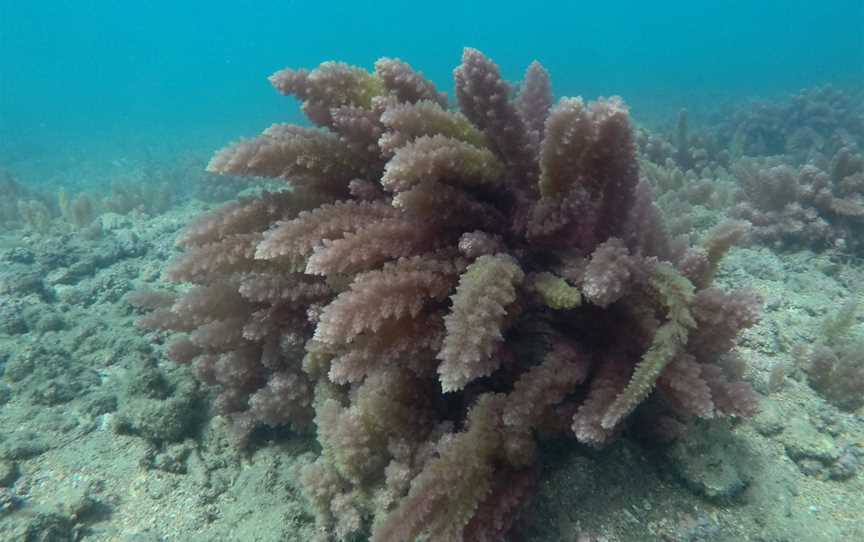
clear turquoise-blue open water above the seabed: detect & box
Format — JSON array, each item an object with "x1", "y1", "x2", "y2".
[{"x1": 0, "y1": 0, "x2": 864, "y2": 187}]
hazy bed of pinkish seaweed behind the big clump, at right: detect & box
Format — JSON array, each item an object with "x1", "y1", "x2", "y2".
[{"x1": 637, "y1": 85, "x2": 864, "y2": 253}]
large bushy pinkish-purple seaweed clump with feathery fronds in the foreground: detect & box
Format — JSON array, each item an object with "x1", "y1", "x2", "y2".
[{"x1": 138, "y1": 49, "x2": 760, "y2": 542}]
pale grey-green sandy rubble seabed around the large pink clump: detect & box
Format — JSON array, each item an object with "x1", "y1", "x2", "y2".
[{"x1": 0, "y1": 202, "x2": 864, "y2": 542}]
